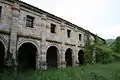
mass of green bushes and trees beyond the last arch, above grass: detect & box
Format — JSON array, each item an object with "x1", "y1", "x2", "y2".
[{"x1": 85, "y1": 37, "x2": 120, "y2": 64}]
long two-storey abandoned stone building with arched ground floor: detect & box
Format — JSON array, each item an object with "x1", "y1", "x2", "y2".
[{"x1": 0, "y1": 0, "x2": 104, "y2": 71}]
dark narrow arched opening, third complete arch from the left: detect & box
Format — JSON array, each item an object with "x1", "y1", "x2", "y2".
[{"x1": 65, "y1": 48, "x2": 73, "y2": 67}]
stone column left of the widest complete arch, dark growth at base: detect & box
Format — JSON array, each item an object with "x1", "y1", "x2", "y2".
[{"x1": 6, "y1": 3, "x2": 20, "y2": 69}]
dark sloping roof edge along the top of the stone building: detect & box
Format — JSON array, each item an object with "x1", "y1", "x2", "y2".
[{"x1": 5, "y1": 0, "x2": 105, "y2": 41}]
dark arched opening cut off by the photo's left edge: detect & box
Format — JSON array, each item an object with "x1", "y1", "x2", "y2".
[{"x1": 0, "y1": 42, "x2": 5, "y2": 72}]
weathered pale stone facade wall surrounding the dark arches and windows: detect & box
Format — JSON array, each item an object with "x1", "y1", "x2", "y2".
[{"x1": 0, "y1": 0, "x2": 104, "y2": 69}]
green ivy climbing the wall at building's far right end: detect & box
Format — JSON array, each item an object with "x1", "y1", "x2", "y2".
[{"x1": 85, "y1": 31, "x2": 106, "y2": 64}]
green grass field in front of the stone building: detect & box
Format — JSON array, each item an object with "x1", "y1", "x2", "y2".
[{"x1": 0, "y1": 63, "x2": 120, "y2": 80}]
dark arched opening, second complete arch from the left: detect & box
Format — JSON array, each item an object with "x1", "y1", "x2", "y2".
[{"x1": 46, "y1": 46, "x2": 58, "y2": 68}]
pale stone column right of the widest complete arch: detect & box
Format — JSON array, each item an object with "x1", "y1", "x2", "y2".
[{"x1": 39, "y1": 15, "x2": 47, "y2": 69}]
